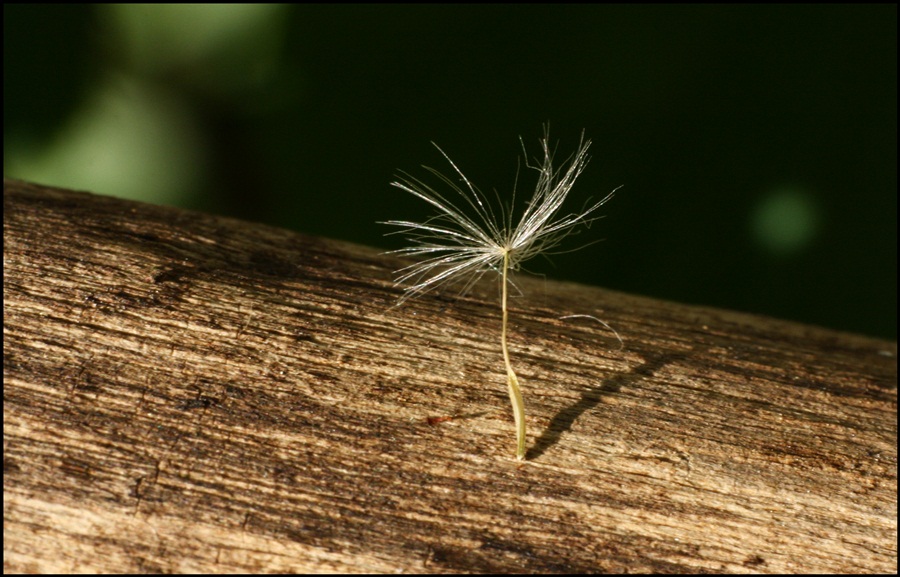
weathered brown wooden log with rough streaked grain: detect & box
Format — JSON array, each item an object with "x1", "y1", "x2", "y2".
[{"x1": 3, "y1": 181, "x2": 897, "y2": 573}]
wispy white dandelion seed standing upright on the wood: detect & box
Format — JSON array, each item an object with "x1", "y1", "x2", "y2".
[{"x1": 383, "y1": 126, "x2": 618, "y2": 460}]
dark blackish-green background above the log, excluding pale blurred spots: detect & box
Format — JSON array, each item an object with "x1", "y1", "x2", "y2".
[{"x1": 3, "y1": 5, "x2": 897, "y2": 339}]
